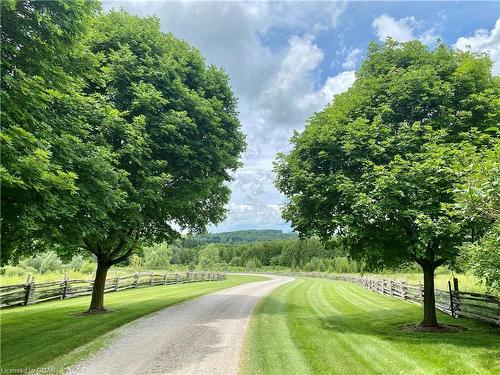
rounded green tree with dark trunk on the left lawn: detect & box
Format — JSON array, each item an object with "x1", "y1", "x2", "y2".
[{"x1": 73, "y1": 11, "x2": 245, "y2": 311}]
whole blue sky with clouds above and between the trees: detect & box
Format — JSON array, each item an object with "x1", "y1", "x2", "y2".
[{"x1": 104, "y1": 0, "x2": 500, "y2": 232}]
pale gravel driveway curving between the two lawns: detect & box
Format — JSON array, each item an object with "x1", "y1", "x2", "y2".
[{"x1": 68, "y1": 276, "x2": 293, "y2": 375}]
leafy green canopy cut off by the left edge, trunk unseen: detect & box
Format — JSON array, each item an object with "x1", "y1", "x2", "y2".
[{"x1": 0, "y1": 1, "x2": 102, "y2": 262}]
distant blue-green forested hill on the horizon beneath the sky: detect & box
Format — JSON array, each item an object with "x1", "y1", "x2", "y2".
[{"x1": 190, "y1": 229, "x2": 298, "y2": 244}]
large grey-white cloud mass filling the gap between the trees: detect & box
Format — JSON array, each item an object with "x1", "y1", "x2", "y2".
[{"x1": 103, "y1": 1, "x2": 354, "y2": 231}]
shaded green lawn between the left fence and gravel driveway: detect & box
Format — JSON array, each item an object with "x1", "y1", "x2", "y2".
[{"x1": 0, "y1": 275, "x2": 266, "y2": 371}]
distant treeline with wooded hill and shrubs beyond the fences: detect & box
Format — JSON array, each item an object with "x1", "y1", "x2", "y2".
[{"x1": 0, "y1": 230, "x2": 364, "y2": 276}]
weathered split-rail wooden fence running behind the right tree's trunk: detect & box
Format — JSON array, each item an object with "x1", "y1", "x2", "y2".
[{"x1": 254, "y1": 272, "x2": 500, "y2": 325}]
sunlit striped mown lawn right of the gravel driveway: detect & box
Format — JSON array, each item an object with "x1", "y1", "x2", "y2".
[{"x1": 242, "y1": 278, "x2": 500, "y2": 375}]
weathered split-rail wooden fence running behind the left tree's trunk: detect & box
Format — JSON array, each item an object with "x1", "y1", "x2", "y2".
[{"x1": 0, "y1": 272, "x2": 226, "y2": 307}]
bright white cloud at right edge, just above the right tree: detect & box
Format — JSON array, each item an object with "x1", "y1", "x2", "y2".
[{"x1": 454, "y1": 18, "x2": 500, "y2": 75}]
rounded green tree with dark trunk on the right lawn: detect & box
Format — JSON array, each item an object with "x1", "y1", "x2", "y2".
[{"x1": 275, "y1": 39, "x2": 500, "y2": 326}]
